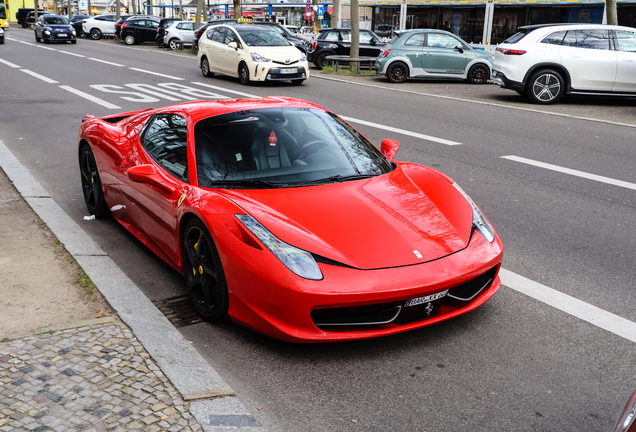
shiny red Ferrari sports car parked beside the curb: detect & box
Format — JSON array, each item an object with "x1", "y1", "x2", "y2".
[{"x1": 79, "y1": 97, "x2": 503, "y2": 342}]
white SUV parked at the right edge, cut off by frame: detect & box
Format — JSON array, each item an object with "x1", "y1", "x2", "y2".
[{"x1": 492, "y1": 24, "x2": 636, "y2": 104}]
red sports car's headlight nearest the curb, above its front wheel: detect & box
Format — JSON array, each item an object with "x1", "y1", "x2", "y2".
[{"x1": 234, "y1": 213, "x2": 323, "y2": 280}]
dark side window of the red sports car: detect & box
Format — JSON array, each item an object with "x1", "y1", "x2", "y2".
[{"x1": 141, "y1": 114, "x2": 188, "y2": 181}]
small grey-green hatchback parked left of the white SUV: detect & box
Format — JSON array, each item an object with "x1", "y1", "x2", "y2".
[{"x1": 375, "y1": 29, "x2": 493, "y2": 84}]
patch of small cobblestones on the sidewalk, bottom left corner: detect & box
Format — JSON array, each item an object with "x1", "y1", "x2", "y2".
[{"x1": 0, "y1": 322, "x2": 201, "y2": 432}]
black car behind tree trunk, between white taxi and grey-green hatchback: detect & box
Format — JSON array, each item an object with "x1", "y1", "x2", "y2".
[{"x1": 307, "y1": 28, "x2": 385, "y2": 69}]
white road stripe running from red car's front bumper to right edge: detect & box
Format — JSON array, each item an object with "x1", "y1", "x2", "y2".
[{"x1": 499, "y1": 268, "x2": 636, "y2": 342}]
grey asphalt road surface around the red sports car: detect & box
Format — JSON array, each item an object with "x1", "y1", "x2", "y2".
[{"x1": 0, "y1": 29, "x2": 636, "y2": 432}]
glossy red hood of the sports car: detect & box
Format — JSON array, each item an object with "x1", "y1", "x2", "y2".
[{"x1": 223, "y1": 164, "x2": 472, "y2": 269}]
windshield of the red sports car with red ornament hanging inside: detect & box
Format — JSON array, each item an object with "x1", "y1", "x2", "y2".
[{"x1": 194, "y1": 108, "x2": 393, "y2": 189}]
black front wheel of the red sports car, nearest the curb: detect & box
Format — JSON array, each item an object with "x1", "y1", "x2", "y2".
[{"x1": 181, "y1": 218, "x2": 229, "y2": 322}]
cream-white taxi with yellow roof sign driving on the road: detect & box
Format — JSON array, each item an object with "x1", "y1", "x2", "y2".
[{"x1": 198, "y1": 24, "x2": 309, "y2": 84}]
